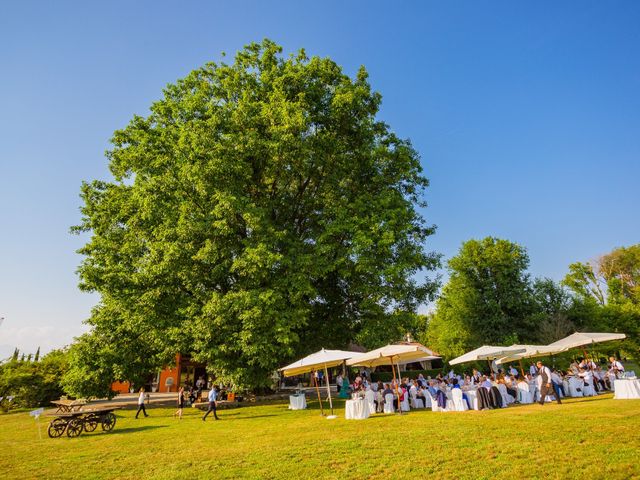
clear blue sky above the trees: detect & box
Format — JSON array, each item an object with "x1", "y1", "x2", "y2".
[{"x1": 0, "y1": 0, "x2": 640, "y2": 358}]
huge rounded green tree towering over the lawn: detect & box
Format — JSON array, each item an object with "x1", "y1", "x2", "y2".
[{"x1": 70, "y1": 40, "x2": 438, "y2": 387}]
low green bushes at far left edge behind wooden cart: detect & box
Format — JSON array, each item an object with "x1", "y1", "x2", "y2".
[{"x1": 0, "y1": 350, "x2": 68, "y2": 409}]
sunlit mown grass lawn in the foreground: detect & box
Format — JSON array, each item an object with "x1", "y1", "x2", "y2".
[{"x1": 0, "y1": 395, "x2": 640, "y2": 480}]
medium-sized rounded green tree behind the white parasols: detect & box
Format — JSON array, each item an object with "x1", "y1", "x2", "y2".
[{"x1": 427, "y1": 237, "x2": 536, "y2": 357}]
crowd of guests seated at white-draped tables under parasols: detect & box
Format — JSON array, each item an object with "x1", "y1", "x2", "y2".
[{"x1": 336, "y1": 357, "x2": 624, "y2": 412}]
